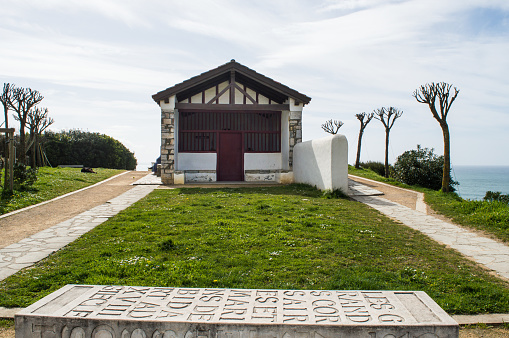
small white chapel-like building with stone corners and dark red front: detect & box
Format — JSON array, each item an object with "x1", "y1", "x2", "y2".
[{"x1": 152, "y1": 60, "x2": 311, "y2": 184}]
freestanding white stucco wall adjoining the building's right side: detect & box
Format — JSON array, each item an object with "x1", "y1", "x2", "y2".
[{"x1": 293, "y1": 135, "x2": 348, "y2": 194}]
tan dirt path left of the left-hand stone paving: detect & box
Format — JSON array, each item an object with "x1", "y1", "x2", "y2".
[{"x1": 0, "y1": 171, "x2": 149, "y2": 248}]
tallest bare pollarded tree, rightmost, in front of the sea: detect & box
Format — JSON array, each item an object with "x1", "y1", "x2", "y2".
[{"x1": 413, "y1": 82, "x2": 460, "y2": 192}]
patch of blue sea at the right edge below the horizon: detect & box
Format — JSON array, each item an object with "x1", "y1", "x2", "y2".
[{"x1": 451, "y1": 165, "x2": 509, "y2": 200}]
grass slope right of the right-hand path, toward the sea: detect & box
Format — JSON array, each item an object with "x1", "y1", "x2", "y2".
[{"x1": 348, "y1": 167, "x2": 509, "y2": 243}]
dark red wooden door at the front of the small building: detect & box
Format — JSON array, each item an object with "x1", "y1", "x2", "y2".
[{"x1": 217, "y1": 133, "x2": 244, "y2": 181}]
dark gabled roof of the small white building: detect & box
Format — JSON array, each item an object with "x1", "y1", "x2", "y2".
[{"x1": 152, "y1": 60, "x2": 311, "y2": 104}]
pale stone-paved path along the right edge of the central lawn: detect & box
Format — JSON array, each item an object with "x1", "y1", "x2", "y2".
[{"x1": 352, "y1": 196, "x2": 509, "y2": 279}]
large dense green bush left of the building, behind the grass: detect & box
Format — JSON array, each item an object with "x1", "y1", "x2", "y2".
[{"x1": 42, "y1": 130, "x2": 137, "y2": 170}]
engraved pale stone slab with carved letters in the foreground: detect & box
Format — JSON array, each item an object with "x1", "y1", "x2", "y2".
[{"x1": 15, "y1": 285, "x2": 459, "y2": 338}]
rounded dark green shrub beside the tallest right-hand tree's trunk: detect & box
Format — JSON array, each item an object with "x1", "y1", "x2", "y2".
[{"x1": 394, "y1": 145, "x2": 458, "y2": 191}]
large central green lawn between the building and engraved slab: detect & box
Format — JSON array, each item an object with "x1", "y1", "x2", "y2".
[{"x1": 0, "y1": 185, "x2": 509, "y2": 314}]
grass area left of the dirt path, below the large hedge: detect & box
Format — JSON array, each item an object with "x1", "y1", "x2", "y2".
[{"x1": 0, "y1": 167, "x2": 125, "y2": 215}]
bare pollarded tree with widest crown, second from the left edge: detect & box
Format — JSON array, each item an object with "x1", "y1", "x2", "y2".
[{"x1": 11, "y1": 87, "x2": 44, "y2": 164}]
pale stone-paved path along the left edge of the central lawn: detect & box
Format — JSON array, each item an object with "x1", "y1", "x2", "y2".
[{"x1": 0, "y1": 184, "x2": 157, "y2": 280}]
